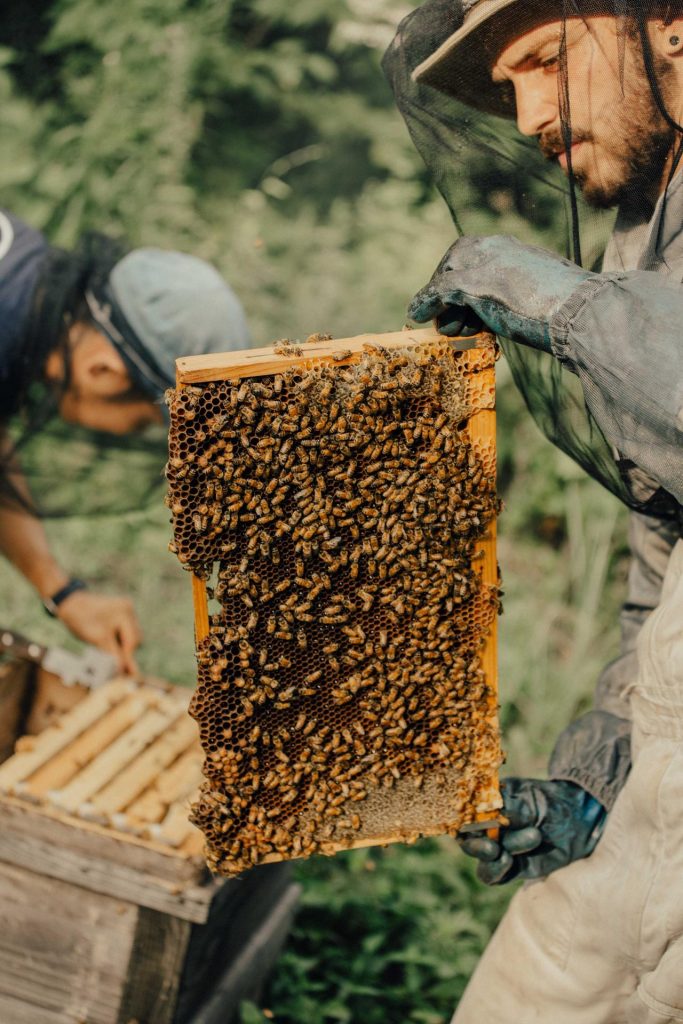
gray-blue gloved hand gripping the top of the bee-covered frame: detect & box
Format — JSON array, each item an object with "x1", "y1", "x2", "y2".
[{"x1": 408, "y1": 236, "x2": 597, "y2": 351}]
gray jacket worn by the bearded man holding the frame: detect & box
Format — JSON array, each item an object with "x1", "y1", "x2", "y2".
[{"x1": 549, "y1": 173, "x2": 683, "y2": 808}]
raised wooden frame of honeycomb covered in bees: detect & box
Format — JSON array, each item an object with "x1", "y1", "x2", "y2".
[{"x1": 168, "y1": 330, "x2": 501, "y2": 873}]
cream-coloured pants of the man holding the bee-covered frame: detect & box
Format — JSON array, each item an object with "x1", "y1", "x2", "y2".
[{"x1": 453, "y1": 541, "x2": 683, "y2": 1024}]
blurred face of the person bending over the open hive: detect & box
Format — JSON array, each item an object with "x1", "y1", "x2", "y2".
[{"x1": 45, "y1": 323, "x2": 163, "y2": 434}]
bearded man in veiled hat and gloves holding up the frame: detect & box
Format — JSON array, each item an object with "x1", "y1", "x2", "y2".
[{"x1": 385, "y1": 0, "x2": 683, "y2": 1024}]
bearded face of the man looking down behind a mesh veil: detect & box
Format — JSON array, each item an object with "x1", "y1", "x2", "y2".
[{"x1": 492, "y1": 16, "x2": 676, "y2": 207}]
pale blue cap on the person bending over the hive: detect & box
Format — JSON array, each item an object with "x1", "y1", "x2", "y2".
[{"x1": 86, "y1": 249, "x2": 250, "y2": 408}]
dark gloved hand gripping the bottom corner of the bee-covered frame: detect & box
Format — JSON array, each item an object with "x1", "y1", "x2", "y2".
[{"x1": 459, "y1": 778, "x2": 607, "y2": 886}]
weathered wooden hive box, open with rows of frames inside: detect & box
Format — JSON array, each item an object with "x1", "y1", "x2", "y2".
[{"x1": 0, "y1": 665, "x2": 296, "y2": 1024}]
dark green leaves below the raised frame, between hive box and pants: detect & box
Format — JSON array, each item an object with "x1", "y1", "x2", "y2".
[{"x1": 242, "y1": 840, "x2": 510, "y2": 1024}]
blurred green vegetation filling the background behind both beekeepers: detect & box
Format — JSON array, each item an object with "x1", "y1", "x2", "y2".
[{"x1": 0, "y1": 0, "x2": 625, "y2": 1024}]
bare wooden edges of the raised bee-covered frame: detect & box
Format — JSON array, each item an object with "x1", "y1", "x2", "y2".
[{"x1": 176, "y1": 321, "x2": 502, "y2": 862}]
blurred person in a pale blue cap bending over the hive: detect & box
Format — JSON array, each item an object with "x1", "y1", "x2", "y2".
[{"x1": 0, "y1": 211, "x2": 249, "y2": 673}]
